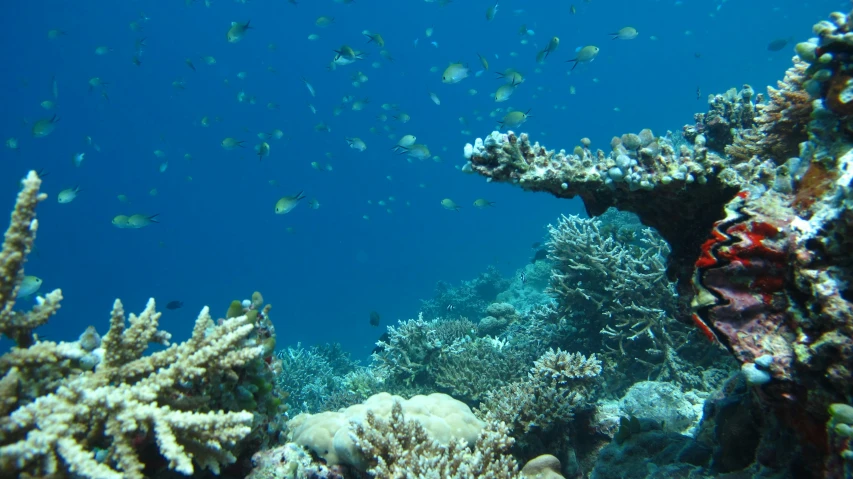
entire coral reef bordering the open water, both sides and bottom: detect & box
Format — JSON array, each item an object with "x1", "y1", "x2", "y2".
[{"x1": 5, "y1": 6, "x2": 853, "y2": 479}]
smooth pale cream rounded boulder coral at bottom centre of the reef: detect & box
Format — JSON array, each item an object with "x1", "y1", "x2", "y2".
[{"x1": 288, "y1": 393, "x2": 485, "y2": 471}]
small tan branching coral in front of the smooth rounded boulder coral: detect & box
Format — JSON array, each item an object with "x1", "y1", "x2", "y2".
[{"x1": 350, "y1": 401, "x2": 522, "y2": 479}]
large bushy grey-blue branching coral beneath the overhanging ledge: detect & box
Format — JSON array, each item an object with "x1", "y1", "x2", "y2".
[{"x1": 547, "y1": 213, "x2": 716, "y2": 392}]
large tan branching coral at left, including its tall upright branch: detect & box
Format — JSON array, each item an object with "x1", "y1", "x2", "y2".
[{"x1": 0, "y1": 172, "x2": 264, "y2": 479}]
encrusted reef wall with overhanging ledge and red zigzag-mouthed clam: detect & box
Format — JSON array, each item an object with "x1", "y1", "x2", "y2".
[{"x1": 465, "y1": 7, "x2": 853, "y2": 477}]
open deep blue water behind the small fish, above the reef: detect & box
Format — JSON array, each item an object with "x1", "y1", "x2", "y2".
[{"x1": 0, "y1": 0, "x2": 848, "y2": 356}]
